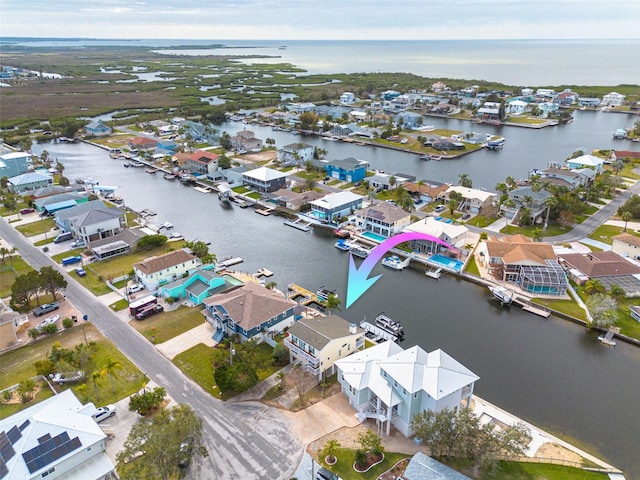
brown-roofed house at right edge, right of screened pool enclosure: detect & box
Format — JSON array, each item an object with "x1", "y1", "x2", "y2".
[{"x1": 558, "y1": 251, "x2": 640, "y2": 297}]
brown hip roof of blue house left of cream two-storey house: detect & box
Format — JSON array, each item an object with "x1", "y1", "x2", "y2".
[{"x1": 204, "y1": 282, "x2": 297, "y2": 331}]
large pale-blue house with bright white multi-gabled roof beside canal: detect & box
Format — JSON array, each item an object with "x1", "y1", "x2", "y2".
[{"x1": 336, "y1": 342, "x2": 479, "y2": 437}]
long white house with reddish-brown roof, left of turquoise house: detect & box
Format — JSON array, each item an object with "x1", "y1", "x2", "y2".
[{"x1": 133, "y1": 250, "x2": 201, "y2": 291}]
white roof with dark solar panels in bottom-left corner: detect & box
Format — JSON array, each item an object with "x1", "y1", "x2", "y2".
[{"x1": 0, "y1": 390, "x2": 114, "y2": 480}]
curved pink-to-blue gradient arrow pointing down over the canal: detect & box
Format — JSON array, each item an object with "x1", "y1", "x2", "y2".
[{"x1": 346, "y1": 232, "x2": 451, "y2": 308}]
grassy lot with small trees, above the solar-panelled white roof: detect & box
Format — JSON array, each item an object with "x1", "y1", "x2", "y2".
[{"x1": 0, "y1": 323, "x2": 144, "y2": 418}]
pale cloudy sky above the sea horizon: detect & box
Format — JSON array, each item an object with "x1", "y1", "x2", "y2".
[{"x1": 0, "y1": 0, "x2": 640, "y2": 40}]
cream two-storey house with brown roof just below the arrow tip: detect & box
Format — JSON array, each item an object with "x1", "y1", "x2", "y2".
[{"x1": 283, "y1": 315, "x2": 365, "y2": 380}]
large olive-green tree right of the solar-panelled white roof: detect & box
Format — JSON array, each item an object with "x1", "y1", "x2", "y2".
[{"x1": 116, "y1": 405, "x2": 208, "y2": 480}]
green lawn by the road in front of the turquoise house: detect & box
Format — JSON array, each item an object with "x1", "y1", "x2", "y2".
[{"x1": 129, "y1": 306, "x2": 204, "y2": 343}]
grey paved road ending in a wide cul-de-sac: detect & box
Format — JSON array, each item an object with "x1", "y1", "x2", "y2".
[{"x1": 0, "y1": 218, "x2": 303, "y2": 480}]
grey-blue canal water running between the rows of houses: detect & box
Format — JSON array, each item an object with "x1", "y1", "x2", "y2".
[{"x1": 33, "y1": 112, "x2": 640, "y2": 479}]
